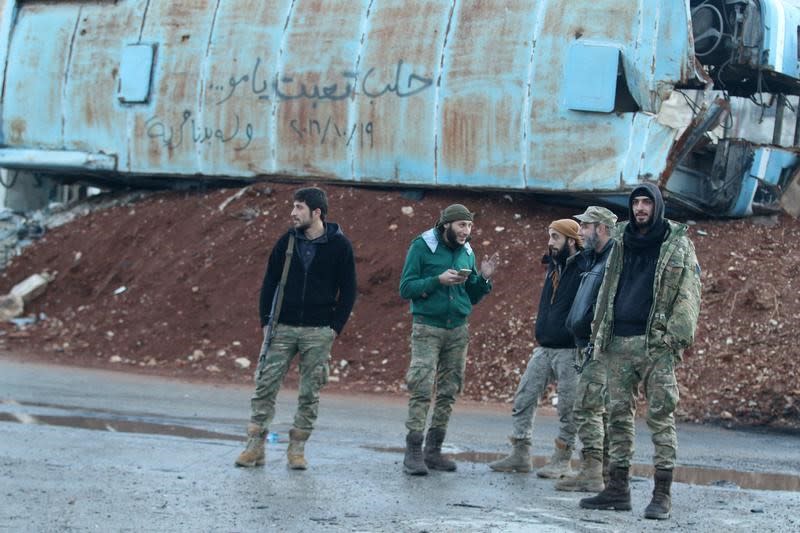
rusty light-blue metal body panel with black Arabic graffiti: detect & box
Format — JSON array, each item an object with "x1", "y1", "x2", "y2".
[{"x1": 3, "y1": 0, "x2": 690, "y2": 190}]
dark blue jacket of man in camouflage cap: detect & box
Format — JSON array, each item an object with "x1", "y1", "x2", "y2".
[{"x1": 566, "y1": 239, "x2": 614, "y2": 348}]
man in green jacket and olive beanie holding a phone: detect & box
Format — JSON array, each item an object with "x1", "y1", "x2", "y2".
[{"x1": 400, "y1": 204, "x2": 500, "y2": 475}]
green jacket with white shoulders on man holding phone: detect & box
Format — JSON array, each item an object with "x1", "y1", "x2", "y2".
[{"x1": 400, "y1": 228, "x2": 492, "y2": 329}]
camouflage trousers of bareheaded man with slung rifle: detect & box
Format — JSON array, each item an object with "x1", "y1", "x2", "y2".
[{"x1": 250, "y1": 324, "x2": 336, "y2": 431}]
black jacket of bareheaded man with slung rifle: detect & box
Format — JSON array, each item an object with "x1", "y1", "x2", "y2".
[{"x1": 259, "y1": 222, "x2": 356, "y2": 334}]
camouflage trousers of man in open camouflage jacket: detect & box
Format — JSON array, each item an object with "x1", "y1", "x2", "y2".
[{"x1": 599, "y1": 335, "x2": 678, "y2": 470}]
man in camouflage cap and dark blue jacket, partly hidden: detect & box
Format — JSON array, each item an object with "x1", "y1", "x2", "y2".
[{"x1": 556, "y1": 205, "x2": 617, "y2": 492}]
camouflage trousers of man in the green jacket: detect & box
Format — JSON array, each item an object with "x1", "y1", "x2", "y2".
[{"x1": 406, "y1": 323, "x2": 469, "y2": 431}]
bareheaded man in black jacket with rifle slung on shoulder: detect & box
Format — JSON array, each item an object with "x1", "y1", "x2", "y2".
[{"x1": 236, "y1": 187, "x2": 356, "y2": 470}]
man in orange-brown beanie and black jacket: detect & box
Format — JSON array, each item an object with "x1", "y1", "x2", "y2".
[{"x1": 489, "y1": 219, "x2": 583, "y2": 478}]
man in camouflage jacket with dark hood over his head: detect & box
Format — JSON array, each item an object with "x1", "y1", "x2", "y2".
[{"x1": 580, "y1": 182, "x2": 700, "y2": 520}]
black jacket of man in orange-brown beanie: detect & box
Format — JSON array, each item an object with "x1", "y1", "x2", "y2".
[{"x1": 536, "y1": 250, "x2": 584, "y2": 348}]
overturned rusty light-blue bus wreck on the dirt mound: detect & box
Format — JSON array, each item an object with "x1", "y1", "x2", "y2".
[{"x1": 0, "y1": 0, "x2": 800, "y2": 217}]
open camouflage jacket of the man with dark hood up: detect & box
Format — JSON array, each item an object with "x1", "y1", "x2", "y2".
[{"x1": 592, "y1": 220, "x2": 700, "y2": 359}]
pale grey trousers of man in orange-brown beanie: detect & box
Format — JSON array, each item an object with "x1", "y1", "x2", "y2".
[{"x1": 511, "y1": 346, "x2": 578, "y2": 446}]
